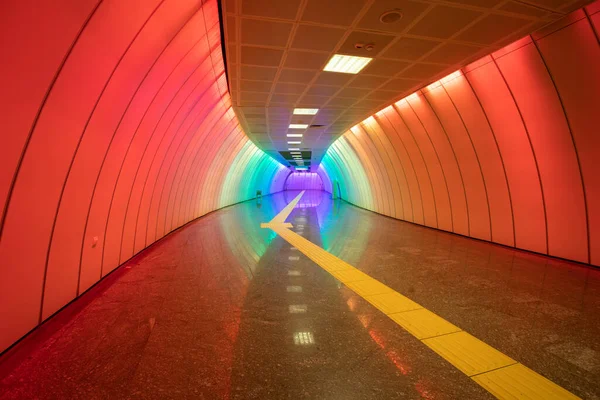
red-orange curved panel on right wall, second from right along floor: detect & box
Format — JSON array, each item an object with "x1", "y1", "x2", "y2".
[{"x1": 496, "y1": 37, "x2": 588, "y2": 262}]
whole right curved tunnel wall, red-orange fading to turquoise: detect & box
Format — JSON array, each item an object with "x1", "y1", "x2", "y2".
[{"x1": 321, "y1": 3, "x2": 600, "y2": 265}]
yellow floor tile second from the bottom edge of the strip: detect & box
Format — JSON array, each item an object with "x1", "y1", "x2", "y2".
[{"x1": 423, "y1": 331, "x2": 516, "y2": 376}]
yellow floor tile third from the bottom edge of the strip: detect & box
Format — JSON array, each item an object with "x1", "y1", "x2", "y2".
[{"x1": 388, "y1": 308, "x2": 460, "y2": 339}]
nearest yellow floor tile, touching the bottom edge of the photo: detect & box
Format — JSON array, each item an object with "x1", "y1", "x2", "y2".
[{"x1": 472, "y1": 364, "x2": 579, "y2": 400}]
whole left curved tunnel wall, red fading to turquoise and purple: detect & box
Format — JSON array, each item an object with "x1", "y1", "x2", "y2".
[{"x1": 0, "y1": 0, "x2": 289, "y2": 352}]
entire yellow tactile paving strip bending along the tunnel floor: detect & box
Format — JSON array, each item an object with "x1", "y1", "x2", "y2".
[{"x1": 261, "y1": 191, "x2": 579, "y2": 400}]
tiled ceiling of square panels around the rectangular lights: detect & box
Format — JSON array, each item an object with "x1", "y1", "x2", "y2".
[{"x1": 222, "y1": 0, "x2": 589, "y2": 169}]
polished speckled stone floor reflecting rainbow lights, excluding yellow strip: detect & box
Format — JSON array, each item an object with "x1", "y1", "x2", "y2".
[{"x1": 0, "y1": 192, "x2": 600, "y2": 399}]
